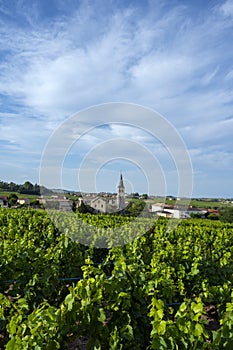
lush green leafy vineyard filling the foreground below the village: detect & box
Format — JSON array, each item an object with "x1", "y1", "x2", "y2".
[{"x1": 0, "y1": 209, "x2": 233, "y2": 350}]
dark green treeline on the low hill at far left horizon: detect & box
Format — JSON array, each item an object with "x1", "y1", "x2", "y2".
[{"x1": 0, "y1": 181, "x2": 53, "y2": 195}]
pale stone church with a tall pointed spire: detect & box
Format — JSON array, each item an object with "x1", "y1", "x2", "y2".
[{"x1": 88, "y1": 174, "x2": 126, "y2": 213}]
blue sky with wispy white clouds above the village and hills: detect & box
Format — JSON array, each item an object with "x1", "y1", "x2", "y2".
[{"x1": 0, "y1": 0, "x2": 233, "y2": 198}]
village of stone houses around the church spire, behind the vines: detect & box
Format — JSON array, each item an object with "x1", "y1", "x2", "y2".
[{"x1": 0, "y1": 174, "x2": 220, "y2": 219}]
